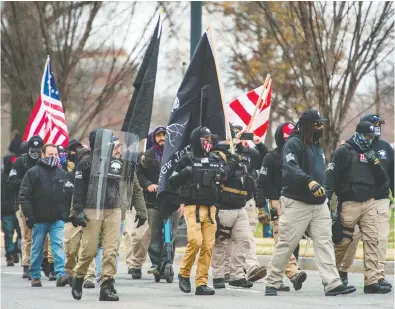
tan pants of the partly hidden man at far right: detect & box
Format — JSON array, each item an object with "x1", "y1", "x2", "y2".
[{"x1": 339, "y1": 199, "x2": 391, "y2": 279}]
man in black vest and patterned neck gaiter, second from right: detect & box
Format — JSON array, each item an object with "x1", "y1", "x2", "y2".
[{"x1": 326, "y1": 121, "x2": 391, "y2": 294}]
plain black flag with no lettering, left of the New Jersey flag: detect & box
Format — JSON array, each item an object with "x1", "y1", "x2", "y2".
[{"x1": 122, "y1": 16, "x2": 162, "y2": 140}]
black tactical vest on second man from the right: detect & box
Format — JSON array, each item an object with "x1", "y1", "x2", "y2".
[{"x1": 347, "y1": 147, "x2": 375, "y2": 202}]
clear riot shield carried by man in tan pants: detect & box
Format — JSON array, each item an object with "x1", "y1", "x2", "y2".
[{"x1": 85, "y1": 129, "x2": 139, "y2": 222}]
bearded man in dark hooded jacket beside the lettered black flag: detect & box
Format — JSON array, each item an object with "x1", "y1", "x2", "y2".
[{"x1": 137, "y1": 126, "x2": 178, "y2": 275}]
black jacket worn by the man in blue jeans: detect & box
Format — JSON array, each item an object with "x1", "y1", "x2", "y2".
[{"x1": 18, "y1": 160, "x2": 73, "y2": 222}]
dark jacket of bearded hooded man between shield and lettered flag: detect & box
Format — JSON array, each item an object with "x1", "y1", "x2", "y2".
[{"x1": 137, "y1": 147, "x2": 160, "y2": 208}]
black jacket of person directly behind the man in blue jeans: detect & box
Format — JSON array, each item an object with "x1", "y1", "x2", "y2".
[{"x1": 8, "y1": 153, "x2": 37, "y2": 211}]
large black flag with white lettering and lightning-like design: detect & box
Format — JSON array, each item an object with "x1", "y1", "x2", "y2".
[{"x1": 158, "y1": 32, "x2": 226, "y2": 218}]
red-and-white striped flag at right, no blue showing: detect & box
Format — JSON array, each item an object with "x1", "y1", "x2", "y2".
[{"x1": 228, "y1": 84, "x2": 272, "y2": 141}]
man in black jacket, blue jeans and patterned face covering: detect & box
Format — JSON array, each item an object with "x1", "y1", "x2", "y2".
[{"x1": 18, "y1": 144, "x2": 73, "y2": 287}]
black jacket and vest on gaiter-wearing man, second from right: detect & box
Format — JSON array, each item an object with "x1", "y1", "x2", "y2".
[{"x1": 325, "y1": 139, "x2": 389, "y2": 202}]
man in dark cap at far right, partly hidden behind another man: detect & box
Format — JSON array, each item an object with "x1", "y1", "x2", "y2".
[{"x1": 339, "y1": 114, "x2": 394, "y2": 283}]
